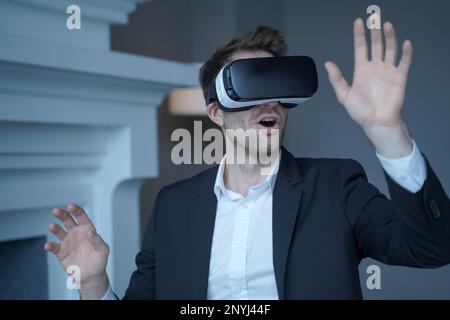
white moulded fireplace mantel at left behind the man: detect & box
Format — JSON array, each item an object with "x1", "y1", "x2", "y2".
[{"x1": 0, "y1": 0, "x2": 198, "y2": 299}]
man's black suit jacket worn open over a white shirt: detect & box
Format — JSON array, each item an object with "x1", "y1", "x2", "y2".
[{"x1": 125, "y1": 149, "x2": 450, "y2": 299}]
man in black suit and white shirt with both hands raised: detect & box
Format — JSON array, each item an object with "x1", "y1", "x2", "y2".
[{"x1": 45, "y1": 19, "x2": 450, "y2": 299}]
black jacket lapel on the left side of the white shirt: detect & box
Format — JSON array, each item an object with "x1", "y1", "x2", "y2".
[{"x1": 189, "y1": 168, "x2": 217, "y2": 300}]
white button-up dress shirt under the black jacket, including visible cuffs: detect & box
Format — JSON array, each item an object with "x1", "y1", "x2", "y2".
[{"x1": 103, "y1": 141, "x2": 426, "y2": 300}]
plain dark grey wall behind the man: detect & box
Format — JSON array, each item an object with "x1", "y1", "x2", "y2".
[{"x1": 111, "y1": 0, "x2": 450, "y2": 299}]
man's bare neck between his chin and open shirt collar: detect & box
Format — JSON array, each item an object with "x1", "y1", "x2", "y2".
[{"x1": 223, "y1": 150, "x2": 280, "y2": 197}]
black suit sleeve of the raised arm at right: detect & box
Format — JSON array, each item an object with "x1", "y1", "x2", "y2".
[{"x1": 341, "y1": 160, "x2": 450, "y2": 268}]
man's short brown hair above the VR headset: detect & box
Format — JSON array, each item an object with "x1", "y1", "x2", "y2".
[{"x1": 199, "y1": 26, "x2": 288, "y2": 100}]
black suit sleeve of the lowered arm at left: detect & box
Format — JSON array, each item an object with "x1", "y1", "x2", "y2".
[{"x1": 123, "y1": 188, "x2": 165, "y2": 300}]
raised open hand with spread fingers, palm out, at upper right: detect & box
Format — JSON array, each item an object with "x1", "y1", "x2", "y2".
[{"x1": 325, "y1": 19, "x2": 412, "y2": 128}]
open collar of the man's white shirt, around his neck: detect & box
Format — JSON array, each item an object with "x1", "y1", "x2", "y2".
[{"x1": 214, "y1": 150, "x2": 281, "y2": 200}]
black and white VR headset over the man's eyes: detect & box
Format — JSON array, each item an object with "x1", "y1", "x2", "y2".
[{"x1": 206, "y1": 56, "x2": 318, "y2": 112}]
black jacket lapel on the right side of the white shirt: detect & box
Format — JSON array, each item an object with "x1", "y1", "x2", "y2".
[{"x1": 272, "y1": 148, "x2": 303, "y2": 299}]
